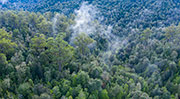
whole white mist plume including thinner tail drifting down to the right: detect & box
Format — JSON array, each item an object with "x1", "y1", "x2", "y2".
[{"x1": 70, "y1": 2, "x2": 128, "y2": 63}]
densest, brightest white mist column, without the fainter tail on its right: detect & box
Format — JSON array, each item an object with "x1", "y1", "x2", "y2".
[{"x1": 71, "y1": 2, "x2": 97, "y2": 43}]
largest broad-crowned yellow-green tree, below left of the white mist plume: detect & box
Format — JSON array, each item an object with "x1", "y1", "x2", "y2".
[{"x1": 49, "y1": 35, "x2": 74, "y2": 72}]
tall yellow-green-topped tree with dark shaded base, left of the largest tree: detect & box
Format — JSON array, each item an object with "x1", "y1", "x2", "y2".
[{"x1": 26, "y1": 33, "x2": 47, "y2": 78}]
